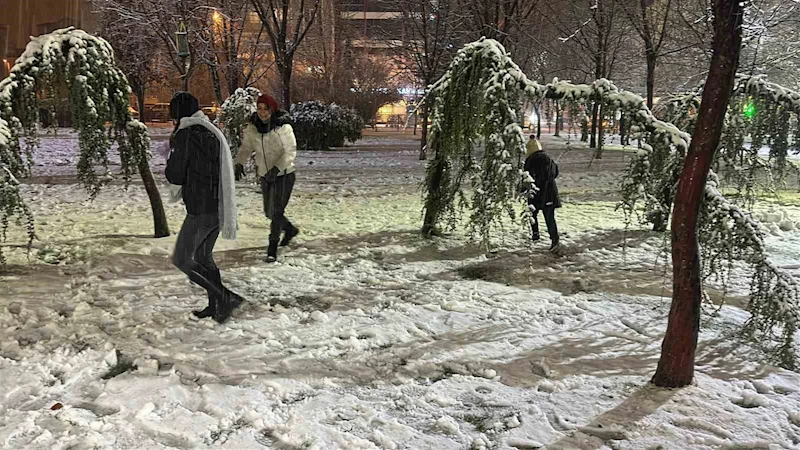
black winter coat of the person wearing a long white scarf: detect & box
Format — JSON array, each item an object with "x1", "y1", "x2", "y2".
[{"x1": 166, "y1": 125, "x2": 220, "y2": 214}]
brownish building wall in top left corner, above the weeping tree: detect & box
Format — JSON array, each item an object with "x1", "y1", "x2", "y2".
[{"x1": 0, "y1": 0, "x2": 97, "y2": 79}]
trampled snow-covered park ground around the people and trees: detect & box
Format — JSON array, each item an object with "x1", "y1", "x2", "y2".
[{"x1": 0, "y1": 137, "x2": 800, "y2": 450}]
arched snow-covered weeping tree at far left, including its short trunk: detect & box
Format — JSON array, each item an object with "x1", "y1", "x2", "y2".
[{"x1": 0, "y1": 28, "x2": 169, "y2": 264}]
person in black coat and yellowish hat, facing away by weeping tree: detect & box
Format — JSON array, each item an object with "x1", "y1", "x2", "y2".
[{"x1": 525, "y1": 135, "x2": 561, "y2": 253}]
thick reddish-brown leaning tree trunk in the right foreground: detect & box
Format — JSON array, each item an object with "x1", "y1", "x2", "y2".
[{"x1": 653, "y1": 0, "x2": 743, "y2": 387}]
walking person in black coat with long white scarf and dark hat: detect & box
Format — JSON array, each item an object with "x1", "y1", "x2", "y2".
[{"x1": 166, "y1": 92, "x2": 242, "y2": 323}]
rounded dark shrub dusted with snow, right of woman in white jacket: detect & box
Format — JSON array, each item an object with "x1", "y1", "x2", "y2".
[{"x1": 290, "y1": 101, "x2": 364, "y2": 150}]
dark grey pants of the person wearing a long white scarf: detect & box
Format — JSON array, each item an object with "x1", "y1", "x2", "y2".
[{"x1": 172, "y1": 213, "x2": 225, "y2": 298}]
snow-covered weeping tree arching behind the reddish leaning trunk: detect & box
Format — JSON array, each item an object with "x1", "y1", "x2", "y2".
[{"x1": 422, "y1": 39, "x2": 800, "y2": 366}]
